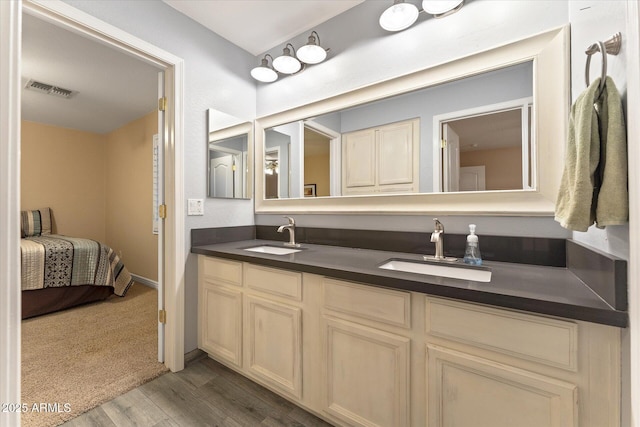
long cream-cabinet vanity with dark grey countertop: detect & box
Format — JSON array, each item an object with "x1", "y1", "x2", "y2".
[{"x1": 192, "y1": 240, "x2": 627, "y2": 427}]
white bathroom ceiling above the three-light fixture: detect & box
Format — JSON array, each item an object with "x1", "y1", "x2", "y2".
[{"x1": 163, "y1": 0, "x2": 364, "y2": 56}]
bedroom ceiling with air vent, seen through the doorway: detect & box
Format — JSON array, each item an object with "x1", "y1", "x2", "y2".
[{"x1": 21, "y1": 14, "x2": 159, "y2": 134}]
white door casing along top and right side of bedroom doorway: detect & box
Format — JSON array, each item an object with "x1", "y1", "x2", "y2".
[{"x1": 16, "y1": 0, "x2": 187, "y2": 378}]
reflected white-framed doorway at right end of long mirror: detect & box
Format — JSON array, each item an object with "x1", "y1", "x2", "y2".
[{"x1": 434, "y1": 98, "x2": 533, "y2": 191}]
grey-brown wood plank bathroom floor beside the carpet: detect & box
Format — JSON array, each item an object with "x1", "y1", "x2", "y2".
[{"x1": 63, "y1": 357, "x2": 331, "y2": 427}]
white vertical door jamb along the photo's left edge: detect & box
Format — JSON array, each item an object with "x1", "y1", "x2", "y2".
[{"x1": 0, "y1": 1, "x2": 22, "y2": 426}]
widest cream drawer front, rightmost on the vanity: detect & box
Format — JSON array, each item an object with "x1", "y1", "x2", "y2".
[{"x1": 426, "y1": 298, "x2": 578, "y2": 371}]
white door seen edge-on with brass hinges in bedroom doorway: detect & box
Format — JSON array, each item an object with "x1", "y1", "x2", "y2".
[{"x1": 154, "y1": 71, "x2": 166, "y2": 363}]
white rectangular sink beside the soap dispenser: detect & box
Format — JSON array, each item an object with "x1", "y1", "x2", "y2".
[{"x1": 379, "y1": 259, "x2": 491, "y2": 282}]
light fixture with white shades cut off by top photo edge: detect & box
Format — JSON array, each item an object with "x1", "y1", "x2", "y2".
[{"x1": 380, "y1": 0, "x2": 464, "y2": 31}]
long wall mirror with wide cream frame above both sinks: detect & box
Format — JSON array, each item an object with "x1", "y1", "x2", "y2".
[{"x1": 255, "y1": 28, "x2": 569, "y2": 215}]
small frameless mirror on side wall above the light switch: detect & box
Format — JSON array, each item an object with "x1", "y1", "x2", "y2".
[{"x1": 207, "y1": 109, "x2": 253, "y2": 199}]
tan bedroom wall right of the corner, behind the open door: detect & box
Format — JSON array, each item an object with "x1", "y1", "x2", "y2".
[{"x1": 105, "y1": 111, "x2": 158, "y2": 281}]
